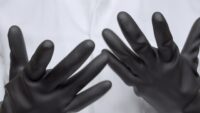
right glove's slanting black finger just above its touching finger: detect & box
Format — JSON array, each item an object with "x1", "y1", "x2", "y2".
[{"x1": 102, "y1": 29, "x2": 143, "y2": 72}]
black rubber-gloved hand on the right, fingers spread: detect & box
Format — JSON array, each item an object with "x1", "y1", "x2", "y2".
[{"x1": 103, "y1": 12, "x2": 200, "y2": 113}]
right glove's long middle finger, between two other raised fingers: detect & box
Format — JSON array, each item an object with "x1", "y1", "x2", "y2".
[{"x1": 118, "y1": 12, "x2": 155, "y2": 62}]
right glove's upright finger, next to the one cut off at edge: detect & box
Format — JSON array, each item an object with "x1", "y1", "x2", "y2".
[{"x1": 152, "y1": 12, "x2": 177, "y2": 61}]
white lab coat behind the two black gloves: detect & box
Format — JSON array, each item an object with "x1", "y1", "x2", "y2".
[{"x1": 0, "y1": 0, "x2": 200, "y2": 113}]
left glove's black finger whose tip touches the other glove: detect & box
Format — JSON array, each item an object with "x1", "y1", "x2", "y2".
[{"x1": 65, "y1": 53, "x2": 108, "y2": 94}]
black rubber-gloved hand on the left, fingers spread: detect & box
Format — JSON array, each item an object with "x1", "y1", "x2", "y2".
[{"x1": 0, "y1": 26, "x2": 111, "y2": 113}]
